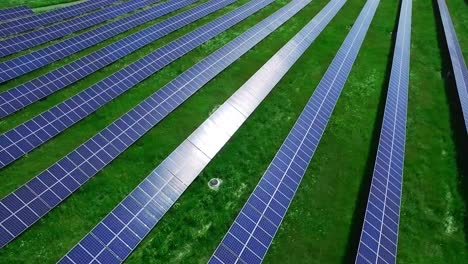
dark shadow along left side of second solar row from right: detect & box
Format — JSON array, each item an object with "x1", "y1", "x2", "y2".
[{"x1": 342, "y1": 1, "x2": 402, "y2": 263}]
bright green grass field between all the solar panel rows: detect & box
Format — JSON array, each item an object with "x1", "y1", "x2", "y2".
[{"x1": 0, "y1": 0, "x2": 468, "y2": 263}]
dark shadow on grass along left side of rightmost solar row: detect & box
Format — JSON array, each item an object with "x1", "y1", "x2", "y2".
[{"x1": 432, "y1": 0, "x2": 468, "y2": 246}]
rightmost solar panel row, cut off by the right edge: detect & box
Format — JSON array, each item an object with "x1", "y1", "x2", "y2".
[{"x1": 437, "y1": 0, "x2": 468, "y2": 132}]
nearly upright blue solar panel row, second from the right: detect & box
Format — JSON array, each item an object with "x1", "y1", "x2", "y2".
[{"x1": 356, "y1": 0, "x2": 412, "y2": 264}]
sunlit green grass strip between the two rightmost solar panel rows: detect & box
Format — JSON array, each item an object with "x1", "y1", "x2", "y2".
[{"x1": 399, "y1": 1, "x2": 468, "y2": 263}]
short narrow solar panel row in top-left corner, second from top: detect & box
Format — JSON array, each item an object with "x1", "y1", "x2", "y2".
[{"x1": 0, "y1": 0, "x2": 118, "y2": 38}]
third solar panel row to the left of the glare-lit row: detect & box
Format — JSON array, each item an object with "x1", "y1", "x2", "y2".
[{"x1": 0, "y1": 0, "x2": 230, "y2": 118}]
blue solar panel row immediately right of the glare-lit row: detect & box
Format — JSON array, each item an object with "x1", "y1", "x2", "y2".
[{"x1": 209, "y1": 0, "x2": 379, "y2": 264}]
